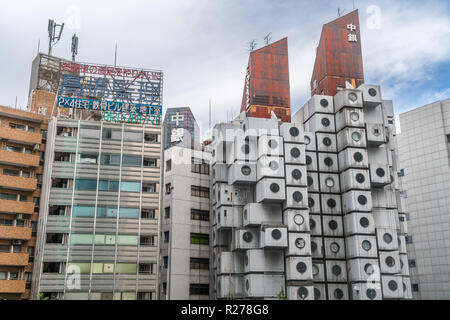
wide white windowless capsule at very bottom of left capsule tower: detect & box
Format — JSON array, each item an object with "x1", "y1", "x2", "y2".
[{"x1": 244, "y1": 274, "x2": 285, "y2": 298}]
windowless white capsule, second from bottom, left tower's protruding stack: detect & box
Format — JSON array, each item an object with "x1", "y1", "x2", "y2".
[{"x1": 244, "y1": 249, "x2": 284, "y2": 273}]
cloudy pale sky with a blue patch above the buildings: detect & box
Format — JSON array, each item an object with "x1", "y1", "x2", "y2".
[{"x1": 0, "y1": 0, "x2": 450, "y2": 136}]
